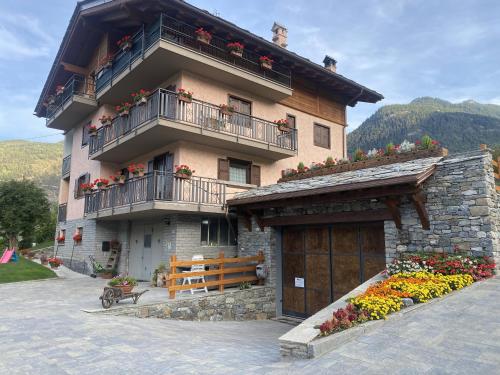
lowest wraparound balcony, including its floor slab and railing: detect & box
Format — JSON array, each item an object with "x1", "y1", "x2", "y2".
[{"x1": 84, "y1": 172, "x2": 226, "y2": 219}]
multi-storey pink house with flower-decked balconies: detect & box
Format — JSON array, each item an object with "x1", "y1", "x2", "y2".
[{"x1": 35, "y1": 0, "x2": 382, "y2": 280}]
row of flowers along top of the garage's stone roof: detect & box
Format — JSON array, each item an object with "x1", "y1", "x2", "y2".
[{"x1": 278, "y1": 137, "x2": 448, "y2": 182}]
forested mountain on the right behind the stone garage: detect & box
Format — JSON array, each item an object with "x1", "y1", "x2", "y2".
[{"x1": 347, "y1": 97, "x2": 500, "y2": 154}]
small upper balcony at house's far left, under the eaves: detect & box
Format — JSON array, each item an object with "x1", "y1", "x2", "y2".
[{"x1": 45, "y1": 75, "x2": 97, "y2": 131}]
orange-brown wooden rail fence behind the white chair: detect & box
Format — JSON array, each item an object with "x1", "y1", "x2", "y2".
[{"x1": 168, "y1": 251, "x2": 264, "y2": 299}]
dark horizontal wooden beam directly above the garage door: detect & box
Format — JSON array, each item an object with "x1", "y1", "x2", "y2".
[{"x1": 262, "y1": 209, "x2": 392, "y2": 227}]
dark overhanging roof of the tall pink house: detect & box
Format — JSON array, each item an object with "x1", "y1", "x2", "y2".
[{"x1": 35, "y1": 0, "x2": 384, "y2": 115}]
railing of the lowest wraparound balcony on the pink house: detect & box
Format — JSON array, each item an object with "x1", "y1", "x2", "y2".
[{"x1": 84, "y1": 171, "x2": 226, "y2": 214}]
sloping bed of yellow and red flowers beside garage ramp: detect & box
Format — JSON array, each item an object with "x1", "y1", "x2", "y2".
[{"x1": 315, "y1": 253, "x2": 495, "y2": 336}]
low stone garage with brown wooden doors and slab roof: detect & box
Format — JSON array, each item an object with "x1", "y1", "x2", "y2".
[{"x1": 228, "y1": 150, "x2": 500, "y2": 320}]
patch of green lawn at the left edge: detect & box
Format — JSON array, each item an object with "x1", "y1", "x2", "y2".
[{"x1": 0, "y1": 257, "x2": 56, "y2": 284}]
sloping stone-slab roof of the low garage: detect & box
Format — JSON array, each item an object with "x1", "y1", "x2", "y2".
[{"x1": 227, "y1": 157, "x2": 442, "y2": 206}]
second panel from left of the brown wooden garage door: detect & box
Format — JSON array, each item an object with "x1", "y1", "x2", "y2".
[{"x1": 305, "y1": 226, "x2": 332, "y2": 316}]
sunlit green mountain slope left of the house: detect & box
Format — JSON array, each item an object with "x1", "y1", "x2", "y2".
[{"x1": 0, "y1": 141, "x2": 63, "y2": 201}]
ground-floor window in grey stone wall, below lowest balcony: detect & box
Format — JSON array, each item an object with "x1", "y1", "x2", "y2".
[{"x1": 201, "y1": 217, "x2": 238, "y2": 246}]
